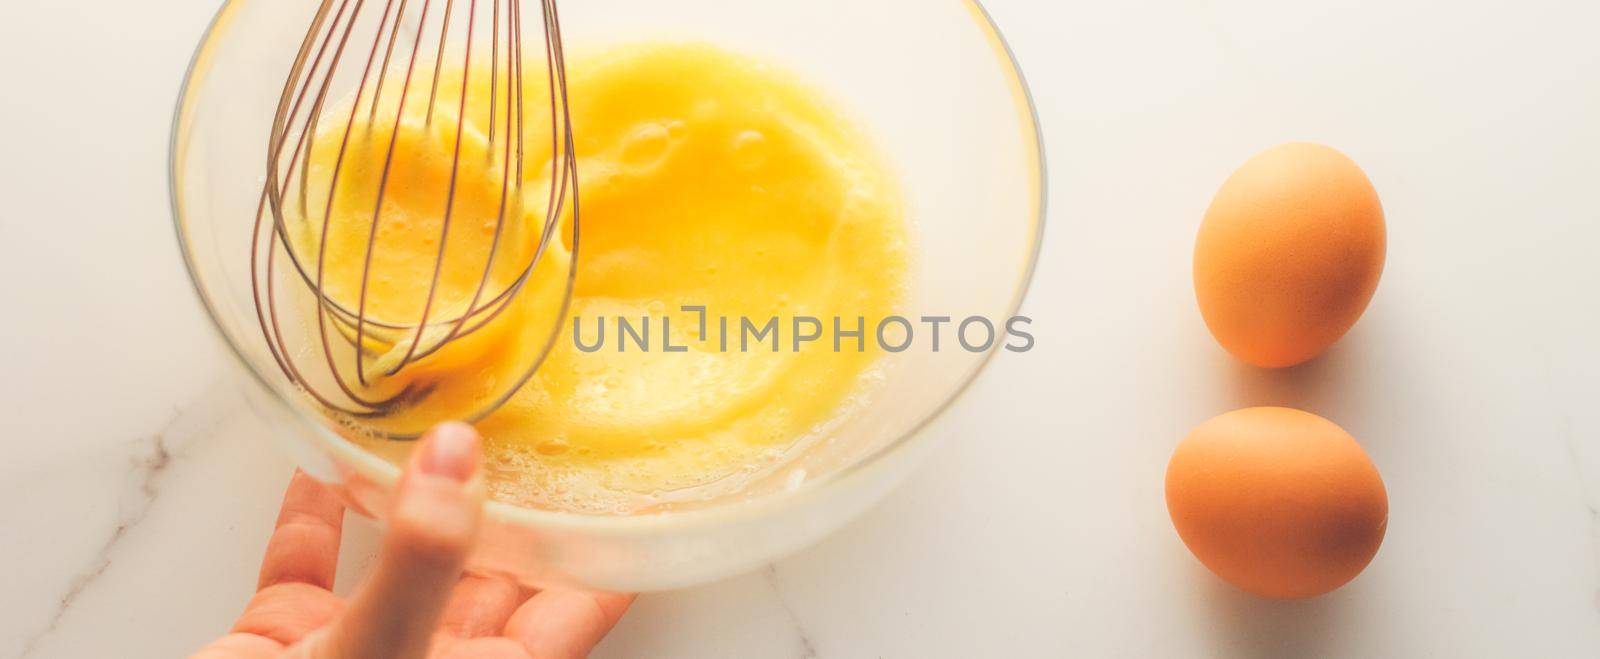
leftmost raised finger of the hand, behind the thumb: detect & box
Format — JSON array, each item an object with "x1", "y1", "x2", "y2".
[{"x1": 256, "y1": 469, "x2": 344, "y2": 590}]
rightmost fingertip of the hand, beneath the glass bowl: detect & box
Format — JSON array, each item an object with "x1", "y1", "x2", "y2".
[{"x1": 506, "y1": 589, "x2": 634, "y2": 659}]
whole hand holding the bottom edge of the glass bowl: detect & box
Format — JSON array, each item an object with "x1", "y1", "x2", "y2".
[{"x1": 195, "y1": 424, "x2": 634, "y2": 659}]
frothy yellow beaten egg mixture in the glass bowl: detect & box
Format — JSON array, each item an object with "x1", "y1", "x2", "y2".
[{"x1": 294, "y1": 43, "x2": 912, "y2": 513}]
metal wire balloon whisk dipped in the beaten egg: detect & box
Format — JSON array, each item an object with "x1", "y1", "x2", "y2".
[{"x1": 250, "y1": 0, "x2": 578, "y2": 438}]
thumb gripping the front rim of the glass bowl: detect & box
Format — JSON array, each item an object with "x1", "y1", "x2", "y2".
[{"x1": 312, "y1": 422, "x2": 483, "y2": 659}]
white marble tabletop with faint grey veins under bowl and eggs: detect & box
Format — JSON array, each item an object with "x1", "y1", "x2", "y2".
[{"x1": 0, "y1": 0, "x2": 1600, "y2": 657}]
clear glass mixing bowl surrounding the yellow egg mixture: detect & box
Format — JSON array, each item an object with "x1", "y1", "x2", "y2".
[{"x1": 171, "y1": 0, "x2": 1045, "y2": 590}]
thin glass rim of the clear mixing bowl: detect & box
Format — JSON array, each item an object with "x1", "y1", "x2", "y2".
[{"x1": 166, "y1": 0, "x2": 1050, "y2": 536}]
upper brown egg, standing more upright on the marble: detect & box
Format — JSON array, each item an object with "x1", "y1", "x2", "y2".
[{"x1": 1194, "y1": 142, "x2": 1386, "y2": 368}]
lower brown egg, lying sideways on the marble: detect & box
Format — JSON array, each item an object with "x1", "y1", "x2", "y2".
[{"x1": 1166, "y1": 408, "x2": 1389, "y2": 598}]
